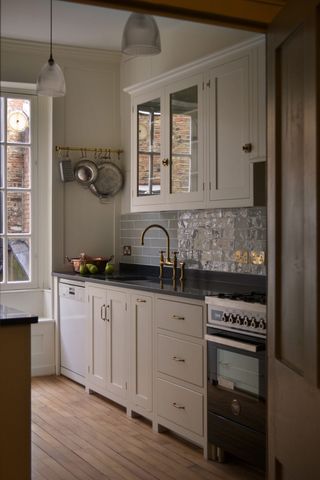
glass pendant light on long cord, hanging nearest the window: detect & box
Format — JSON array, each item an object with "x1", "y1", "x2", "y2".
[{"x1": 37, "y1": 0, "x2": 66, "y2": 97}]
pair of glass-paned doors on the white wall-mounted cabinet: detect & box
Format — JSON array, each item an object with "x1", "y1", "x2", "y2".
[{"x1": 132, "y1": 75, "x2": 204, "y2": 207}]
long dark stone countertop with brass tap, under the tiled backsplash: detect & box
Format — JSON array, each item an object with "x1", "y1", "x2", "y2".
[{"x1": 52, "y1": 264, "x2": 266, "y2": 300}]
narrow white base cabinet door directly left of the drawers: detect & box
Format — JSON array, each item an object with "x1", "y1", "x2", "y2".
[{"x1": 130, "y1": 295, "x2": 153, "y2": 412}]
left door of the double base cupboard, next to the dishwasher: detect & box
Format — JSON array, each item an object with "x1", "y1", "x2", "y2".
[{"x1": 87, "y1": 287, "x2": 108, "y2": 388}]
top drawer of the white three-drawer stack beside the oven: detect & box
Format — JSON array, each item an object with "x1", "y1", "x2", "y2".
[{"x1": 156, "y1": 298, "x2": 203, "y2": 338}]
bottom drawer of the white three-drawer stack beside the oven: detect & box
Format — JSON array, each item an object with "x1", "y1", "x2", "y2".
[{"x1": 157, "y1": 379, "x2": 203, "y2": 436}]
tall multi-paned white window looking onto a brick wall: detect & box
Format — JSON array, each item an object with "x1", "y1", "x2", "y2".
[{"x1": 0, "y1": 92, "x2": 37, "y2": 288}]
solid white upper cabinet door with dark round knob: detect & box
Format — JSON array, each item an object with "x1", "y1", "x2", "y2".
[{"x1": 208, "y1": 54, "x2": 253, "y2": 206}]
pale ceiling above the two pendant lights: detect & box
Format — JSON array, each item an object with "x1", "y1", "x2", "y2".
[{"x1": 1, "y1": 0, "x2": 245, "y2": 51}]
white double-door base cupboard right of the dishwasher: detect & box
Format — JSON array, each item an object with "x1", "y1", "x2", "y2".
[{"x1": 86, "y1": 284, "x2": 129, "y2": 405}]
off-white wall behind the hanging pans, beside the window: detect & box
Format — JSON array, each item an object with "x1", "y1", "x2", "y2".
[{"x1": 1, "y1": 39, "x2": 121, "y2": 278}]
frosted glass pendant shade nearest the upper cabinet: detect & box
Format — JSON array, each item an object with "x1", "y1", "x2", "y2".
[{"x1": 121, "y1": 13, "x2": 161, "y2": 55}]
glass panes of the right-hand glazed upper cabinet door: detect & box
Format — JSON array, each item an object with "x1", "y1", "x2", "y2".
[{"x1": 170, "y1": 84, "x2": 199, "y2": 194}]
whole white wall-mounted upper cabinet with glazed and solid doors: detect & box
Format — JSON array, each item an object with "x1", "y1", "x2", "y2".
[{"x1": 126, "y1": 36, "x2": 266, "y2": 211}]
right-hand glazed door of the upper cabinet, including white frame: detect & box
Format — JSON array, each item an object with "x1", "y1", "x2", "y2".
[{"x1": 164, "y1": 75, "x2": 204, "y2": 204}]
